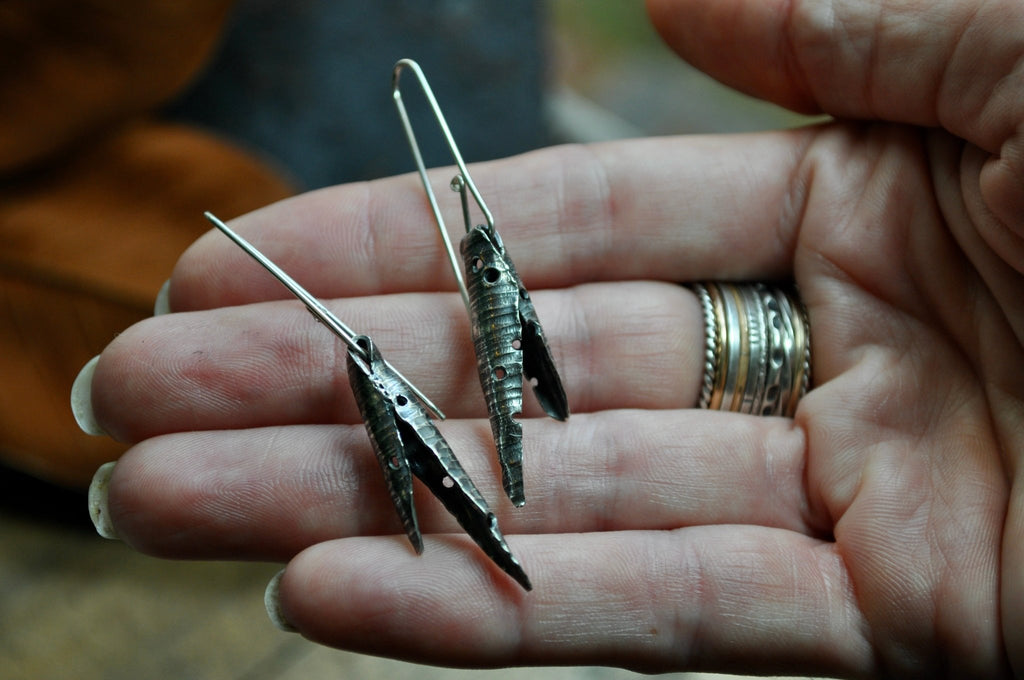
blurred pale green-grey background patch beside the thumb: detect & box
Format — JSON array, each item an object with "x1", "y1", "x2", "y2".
[{"x1": 547, "y1": 0, "x2": 815, "y2": 140}]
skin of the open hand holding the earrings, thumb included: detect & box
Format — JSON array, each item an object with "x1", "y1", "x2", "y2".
[{"x1": 81, "y1": 0, "x2": 1024, "y2": 678}]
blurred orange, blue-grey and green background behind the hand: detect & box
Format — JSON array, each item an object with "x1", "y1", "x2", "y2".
[{"x1": 0, "y1": 0, "x2": 807, "y2": 680}]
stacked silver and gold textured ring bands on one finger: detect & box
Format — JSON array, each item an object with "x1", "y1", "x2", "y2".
[{"x1": 692, "y1": 282, "x2": 811, "y2": 418}]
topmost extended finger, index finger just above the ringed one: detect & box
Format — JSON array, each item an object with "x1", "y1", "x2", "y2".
[{"x1": 170, "y1": 132, "x2": 808, "y2": 311}]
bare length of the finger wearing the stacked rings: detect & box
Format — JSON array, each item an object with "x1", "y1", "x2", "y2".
[{"x1": 92, "y1": 282, "x2": 705, "y2": 441}]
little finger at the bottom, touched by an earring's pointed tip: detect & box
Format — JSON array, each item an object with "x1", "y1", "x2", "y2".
[{"x1": 280, "y1": 526, "x2": 872, "y2": 677}]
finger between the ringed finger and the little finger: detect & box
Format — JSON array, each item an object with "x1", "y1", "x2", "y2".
[{"x1": 96, "y1": 411, "x2": 821, "y2": 559}]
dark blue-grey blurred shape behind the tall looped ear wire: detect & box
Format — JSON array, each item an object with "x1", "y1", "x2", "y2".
[{"x1": 165, "y1": 0, "x2": 548, "y2": 188}]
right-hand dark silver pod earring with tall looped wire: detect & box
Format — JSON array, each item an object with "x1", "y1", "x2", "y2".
[{"x1": 391, "y1": 59, "x2": 569, "y2": 506}]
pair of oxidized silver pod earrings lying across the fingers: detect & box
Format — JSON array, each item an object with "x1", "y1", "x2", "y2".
[{"x1": 199, "y1": 59, "x2": 569, "y2": 590}]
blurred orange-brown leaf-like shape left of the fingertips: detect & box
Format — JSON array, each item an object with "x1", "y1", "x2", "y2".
[{"x1": 0, "y1": 0, "x2": 292, "y2": 486}]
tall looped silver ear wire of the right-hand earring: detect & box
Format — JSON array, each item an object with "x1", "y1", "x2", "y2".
[{"x1": 391, "y1": 59, "x2": 495, "y2": 309}]
